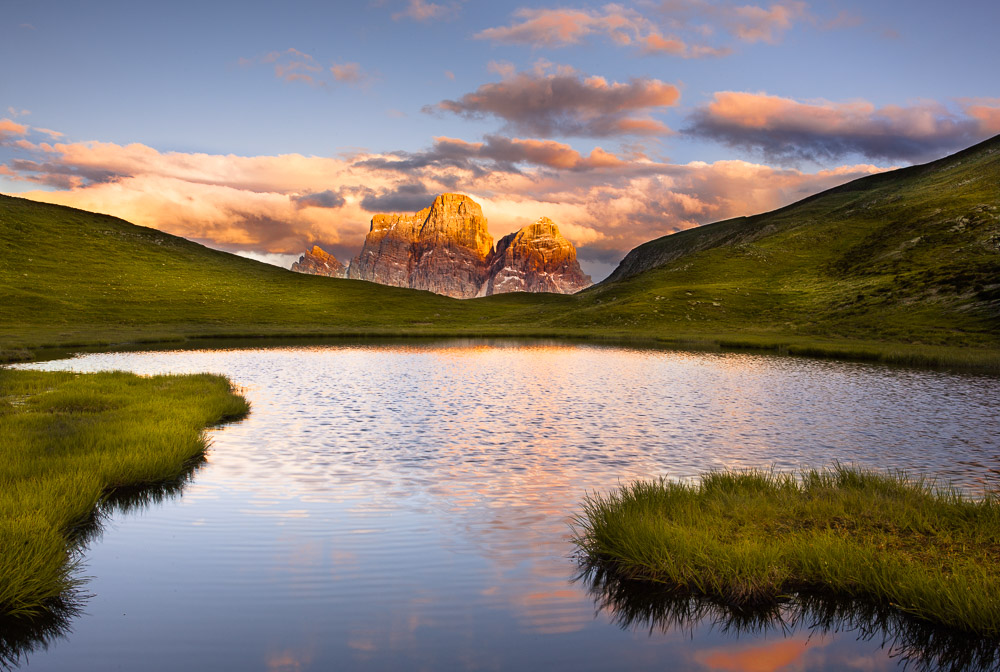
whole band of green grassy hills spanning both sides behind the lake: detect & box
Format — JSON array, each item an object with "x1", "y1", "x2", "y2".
[{"x1": 0, "y1": 138, "x2": 1000, "y2": 368}]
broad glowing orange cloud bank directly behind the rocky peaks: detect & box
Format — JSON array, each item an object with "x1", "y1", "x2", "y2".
[{"x1": 0, "y1": 124, "x2": 892, "y2": 274}]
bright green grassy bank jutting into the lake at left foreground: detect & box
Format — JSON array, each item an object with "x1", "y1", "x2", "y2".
[{"x1": 0, "y1": 369, "x2": 249, "y2": 616}]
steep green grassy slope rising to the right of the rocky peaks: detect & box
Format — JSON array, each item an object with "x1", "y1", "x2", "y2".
[{"x1": 564, "y1": 138, "x2": 1000, "y2": 356}]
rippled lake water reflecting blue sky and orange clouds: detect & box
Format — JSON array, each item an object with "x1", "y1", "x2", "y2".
[{"x1": 9, "y1": 342, "x2": 1000, "y2": 671}]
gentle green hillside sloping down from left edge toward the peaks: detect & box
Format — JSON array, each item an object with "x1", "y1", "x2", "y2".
[{"x1": 0, "y1": 196, "x2": 556, "y2": 348}]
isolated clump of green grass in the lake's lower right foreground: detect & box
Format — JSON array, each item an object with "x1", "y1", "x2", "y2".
[{"x1": 575, "y1": 467, "x2": 1000, "y2": 638}]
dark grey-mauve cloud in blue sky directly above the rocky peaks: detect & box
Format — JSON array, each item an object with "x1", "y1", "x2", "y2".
[{"x1": 424, "y1": 63, "x2": 680, "y2": 137}]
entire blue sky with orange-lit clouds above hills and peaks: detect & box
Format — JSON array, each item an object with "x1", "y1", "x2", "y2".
[{"x1": 0, "y1": 0, "x2": 1000, "y2": 281}]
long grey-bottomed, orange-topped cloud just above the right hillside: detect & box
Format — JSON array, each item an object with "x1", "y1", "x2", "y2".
[{"x1": 685, "y1": 91, "x2": 1000, "y2": 161}]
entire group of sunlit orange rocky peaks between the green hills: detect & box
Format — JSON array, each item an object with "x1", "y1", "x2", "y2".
[{"x1": 292, "y1": 194, "x2": 591, "y2": 299}]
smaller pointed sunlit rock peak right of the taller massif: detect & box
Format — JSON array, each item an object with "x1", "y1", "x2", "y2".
[{"x1": 482, "y1": 217, "x2": 592, "y2": 296}]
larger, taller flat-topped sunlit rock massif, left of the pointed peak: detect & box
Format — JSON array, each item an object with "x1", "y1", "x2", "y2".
[{"x1": 349, "y1": 194, "x2": 493, "y2": 299}]
